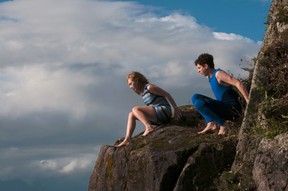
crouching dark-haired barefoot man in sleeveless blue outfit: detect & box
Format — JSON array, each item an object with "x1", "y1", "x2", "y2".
[{"x1": 192, "y1": 53, "x2": 249, "y2": 134}]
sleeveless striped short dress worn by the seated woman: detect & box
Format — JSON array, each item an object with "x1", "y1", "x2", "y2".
[{"x1": 142, "y1": 84, "x2": 172, "y2": 124}]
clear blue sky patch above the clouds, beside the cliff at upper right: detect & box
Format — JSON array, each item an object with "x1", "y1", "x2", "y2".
[{"x1": 123, "y1": 0, "x2": 271, "y2": 41}]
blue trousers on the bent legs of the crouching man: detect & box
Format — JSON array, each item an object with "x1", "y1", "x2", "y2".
[{"x1": 192, "y1": 90, "x2": 242, "y2": 126}]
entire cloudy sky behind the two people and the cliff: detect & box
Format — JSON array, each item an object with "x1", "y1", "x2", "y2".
[{"x1": 0, "y1": 0, "x2": 271, "y2": 191}]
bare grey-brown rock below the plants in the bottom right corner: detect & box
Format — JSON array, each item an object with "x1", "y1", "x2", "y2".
[{"x1": 253, "y1": 133, "x2": 288, "y2": 191}]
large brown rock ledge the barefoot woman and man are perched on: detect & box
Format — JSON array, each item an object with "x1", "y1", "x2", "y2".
[{"x1": 89, "y1": 106, "x2": 237, "y2": 191}]
